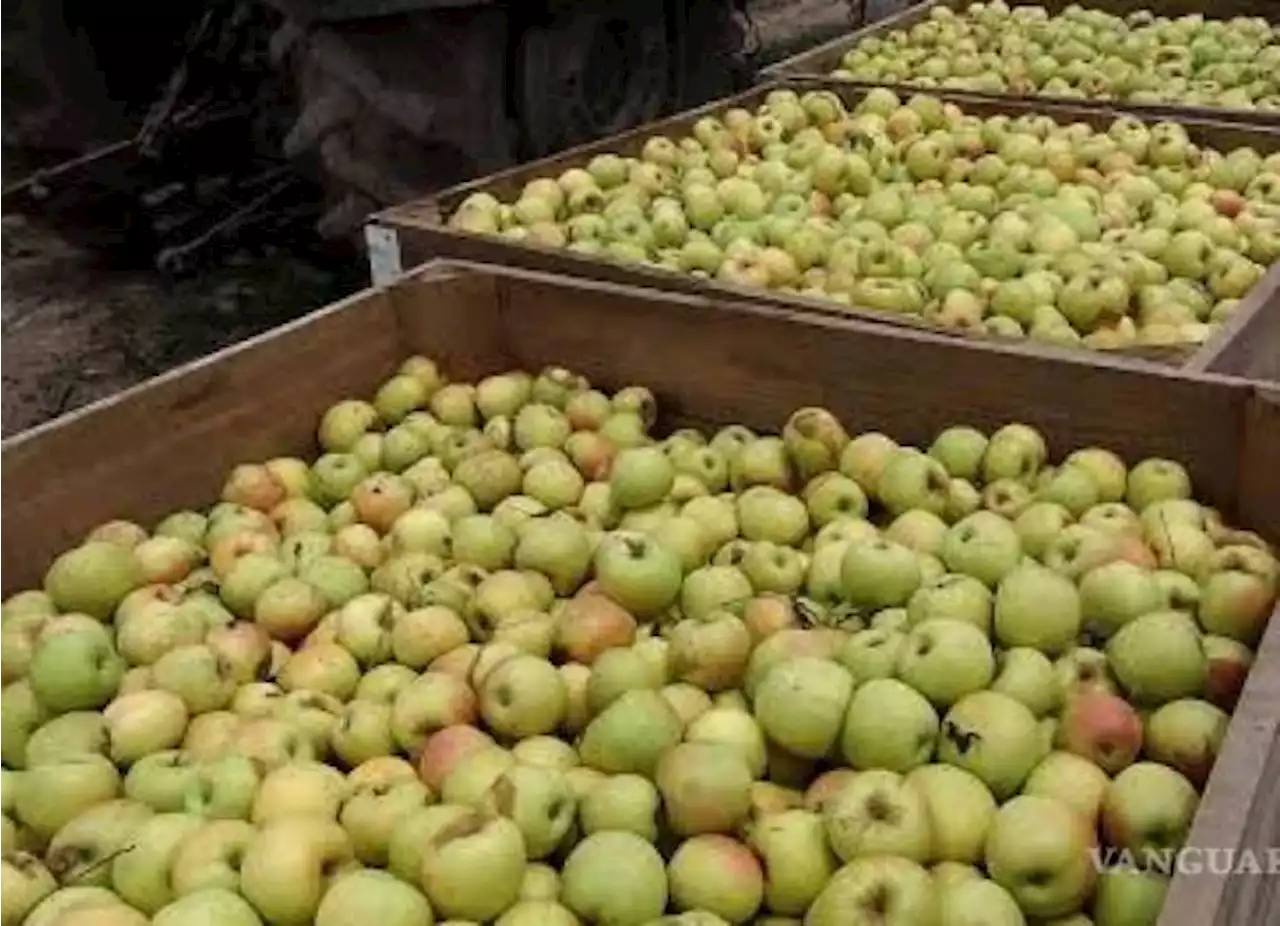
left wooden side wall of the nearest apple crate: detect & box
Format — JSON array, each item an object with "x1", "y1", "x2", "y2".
[{"x1": 0, "y1": 291, "x2": 403, "y2": 597}]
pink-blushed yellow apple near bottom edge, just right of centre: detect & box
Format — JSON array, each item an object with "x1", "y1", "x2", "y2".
[{"x1": 667, "y1": 834, "x2": 764, "y2": 923}]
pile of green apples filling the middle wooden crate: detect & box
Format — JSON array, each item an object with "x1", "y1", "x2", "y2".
[{"x1": 448, "y1": 88, "x2": 1280, "y2": 348}]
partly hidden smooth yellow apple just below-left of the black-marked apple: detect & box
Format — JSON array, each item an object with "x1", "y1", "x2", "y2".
[{"x1": 906, "y1": 765, "x2": 996, "y2": 865}]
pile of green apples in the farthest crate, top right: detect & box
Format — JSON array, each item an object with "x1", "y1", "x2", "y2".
[{"x1": 835, "y1": 0, "x2": 1280, "y2": 110}]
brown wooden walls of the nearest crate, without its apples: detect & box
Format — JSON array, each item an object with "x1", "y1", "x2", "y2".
[{"x1": 0, "y1": 263, "x2": 1280, "y2": 926}]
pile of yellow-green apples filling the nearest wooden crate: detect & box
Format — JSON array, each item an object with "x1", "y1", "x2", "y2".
[{"x1": 0, "y1": 357, "x2": 1280, "y2": 926}]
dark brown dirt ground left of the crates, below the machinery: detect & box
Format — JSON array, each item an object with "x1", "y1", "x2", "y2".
[{"x1": 0, "y1": 215, "x2": 352, "y2": 438}]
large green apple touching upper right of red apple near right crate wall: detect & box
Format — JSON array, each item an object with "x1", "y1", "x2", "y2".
[{"x1": 1106, "y1": 611, "x2": 1208, "y2": 706}]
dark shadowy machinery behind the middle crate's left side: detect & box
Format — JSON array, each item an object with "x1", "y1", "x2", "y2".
[{"x1": 268, "y1": 0, "x2": 742, "y2": 242}]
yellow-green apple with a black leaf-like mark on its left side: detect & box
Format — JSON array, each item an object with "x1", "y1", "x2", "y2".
[{"x1": 938, "y1": 692, "x2": 1042, "y2": 800}]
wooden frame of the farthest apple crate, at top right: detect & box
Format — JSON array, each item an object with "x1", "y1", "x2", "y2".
[{"x1": 760, "y1": 0, "x2": 1280, "y2": 126}]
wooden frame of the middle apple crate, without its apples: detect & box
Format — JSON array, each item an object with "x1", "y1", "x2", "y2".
[{"x1": 365, "y1": 78, "x2": 1280, "y2": 374}]
